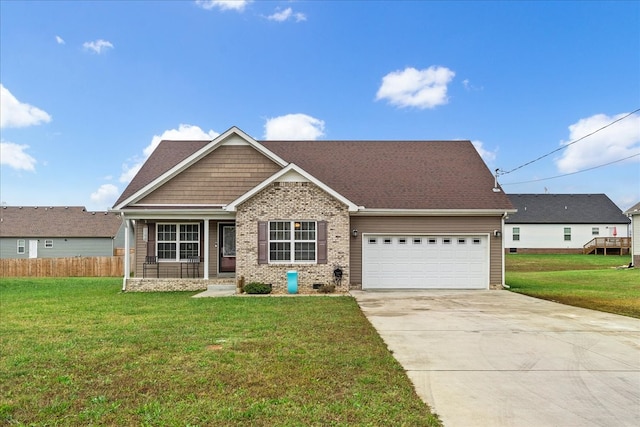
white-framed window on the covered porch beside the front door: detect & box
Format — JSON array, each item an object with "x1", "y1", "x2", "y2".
[{"x1": 157, "y1": 224, "x2": 200, "y2": 261}]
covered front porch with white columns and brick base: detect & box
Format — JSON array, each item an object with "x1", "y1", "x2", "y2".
[{"x1": 122, "y1": 210, "x2": 236, "y2": 292}]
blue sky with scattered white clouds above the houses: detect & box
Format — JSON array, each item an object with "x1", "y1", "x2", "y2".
[{"x1": 0, "y1": 0, "x2": 640, "y2": 210}]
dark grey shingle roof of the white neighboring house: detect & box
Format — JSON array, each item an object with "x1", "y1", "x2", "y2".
[{"x1": 505, "y1": 194, "x2": 630, "y2": 224}]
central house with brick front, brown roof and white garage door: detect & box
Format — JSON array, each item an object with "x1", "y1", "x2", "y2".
[{"x1": 113, "y1": 127, "x2": 513, "y2": 293}]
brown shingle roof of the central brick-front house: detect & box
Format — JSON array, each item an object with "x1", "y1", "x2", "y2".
[{"x1": 115, "y1": 136, "x2": 512, "y2": 210}]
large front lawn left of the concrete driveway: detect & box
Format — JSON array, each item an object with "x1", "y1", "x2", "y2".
[{"x1": 0, "y1": 278, "x2": 441, "y2": 426}]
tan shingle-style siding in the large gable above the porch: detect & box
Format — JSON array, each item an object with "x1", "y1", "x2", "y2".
[{"x1": 138, "y1": 145, "x2": 280, "y2": 205}]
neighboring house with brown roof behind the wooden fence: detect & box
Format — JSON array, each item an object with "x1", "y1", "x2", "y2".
[{"x1": 0, "y1": 206, "x2": 124, "y2": 258}]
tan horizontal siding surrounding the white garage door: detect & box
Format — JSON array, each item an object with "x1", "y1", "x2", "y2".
[{"x1": 350, "y1": 216, "x2": 503, "y2": 285}]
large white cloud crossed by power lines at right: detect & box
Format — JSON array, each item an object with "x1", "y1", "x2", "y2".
[{"x1": 556, "y1": 113, "x2": 640, "y2": 173}]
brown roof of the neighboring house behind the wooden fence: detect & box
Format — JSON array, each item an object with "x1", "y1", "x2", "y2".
[{"x1": 0, "y1": 206, "x2": 122, "y2": 238}]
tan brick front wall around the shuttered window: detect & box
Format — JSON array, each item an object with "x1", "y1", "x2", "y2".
[{"x1": 236, "y1": 182, "x2": 351, "y2": 294}]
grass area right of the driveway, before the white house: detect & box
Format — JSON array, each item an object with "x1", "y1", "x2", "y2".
[{"x1": 505, "y1": 254, "x2": 640, "y2": 318}]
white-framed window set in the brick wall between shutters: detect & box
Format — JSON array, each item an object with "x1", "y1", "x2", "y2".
[{"x1": 269, "y1": 221, "x2": 317, "y2": 262}]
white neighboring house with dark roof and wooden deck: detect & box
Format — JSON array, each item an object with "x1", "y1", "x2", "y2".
[{"x1": 505, "y1": 194, "x2": 629, "y2": 253}]
